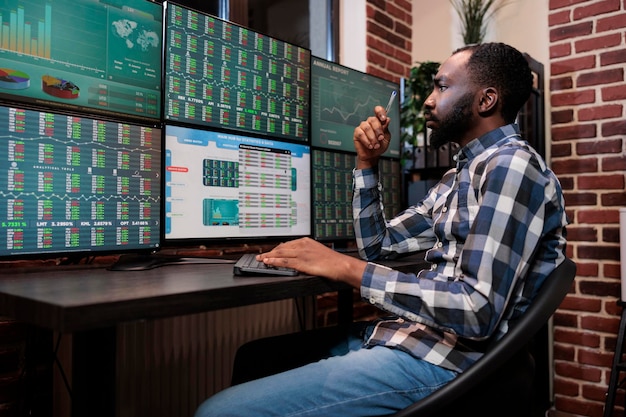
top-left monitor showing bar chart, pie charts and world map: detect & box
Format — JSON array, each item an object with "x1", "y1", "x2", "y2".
[{"x1": 0, "y1": 0, "x2": 163, "y2": 123}]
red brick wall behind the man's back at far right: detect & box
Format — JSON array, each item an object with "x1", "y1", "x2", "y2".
[{"x1": 548, "y1": 0, "x2": 626, "y2": 417}]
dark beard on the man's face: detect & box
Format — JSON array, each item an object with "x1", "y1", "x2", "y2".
[{"x1": 429, "y1": 93, "x2": 474, "y2": 149}]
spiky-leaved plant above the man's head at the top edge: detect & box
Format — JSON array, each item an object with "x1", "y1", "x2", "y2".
[{"x1": 449, "y1": 0, "x2": 508, "y2": 45}]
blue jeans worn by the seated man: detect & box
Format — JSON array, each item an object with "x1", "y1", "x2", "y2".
[{"x1": 195, "y1": 328, "x2": 456, "y2": 417}]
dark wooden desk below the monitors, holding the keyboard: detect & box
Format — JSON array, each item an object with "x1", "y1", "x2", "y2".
[{"x1": 0, "y1": 252, "x2": 423, "y2": 417}]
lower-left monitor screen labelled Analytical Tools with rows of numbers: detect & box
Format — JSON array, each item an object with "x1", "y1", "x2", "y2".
[{"x1": 0, "y1": 107, "x2": 161, "y2": 257}]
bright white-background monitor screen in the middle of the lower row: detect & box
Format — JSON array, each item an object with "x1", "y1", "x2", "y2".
[{"x1": 164, "y1": 125, "x2": 311, "y2": 241}]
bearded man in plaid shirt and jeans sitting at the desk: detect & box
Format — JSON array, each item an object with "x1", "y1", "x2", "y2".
[{"x1": 196, "y1": 43, "x2": 567, "y2": 417}]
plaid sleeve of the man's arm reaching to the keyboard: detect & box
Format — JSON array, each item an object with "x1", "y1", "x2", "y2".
[{"x1": 361, "y1": 148, "x2": 556, "y2": 339}]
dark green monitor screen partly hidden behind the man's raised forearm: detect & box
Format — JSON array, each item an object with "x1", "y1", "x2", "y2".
[{"x1": 311, "y1": 149, "x2": 402, "y2": 242}]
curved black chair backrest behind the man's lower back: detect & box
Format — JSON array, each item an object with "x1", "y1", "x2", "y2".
[{"x1": 392, "y1": 258, "x2": 576, "y2": 417}]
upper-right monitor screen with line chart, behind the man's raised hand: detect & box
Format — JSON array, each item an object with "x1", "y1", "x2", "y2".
[{"x1": 311, "y1": 57, "x2": 400, "y2": 158}]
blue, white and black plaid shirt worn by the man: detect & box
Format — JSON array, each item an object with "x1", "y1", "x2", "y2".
[{"x1": 353, "y1": 124, "x2": 567, "y2": 372}]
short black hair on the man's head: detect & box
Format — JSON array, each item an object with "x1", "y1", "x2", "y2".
[{"x1": 453, "y1": 42, "x2": 533, "y2": 123}]
